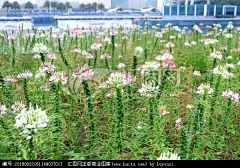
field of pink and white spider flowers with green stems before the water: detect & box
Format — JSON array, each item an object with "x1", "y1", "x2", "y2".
[{"x1": 0, "y1": 19, "x2": 240, "y2": 160}]
